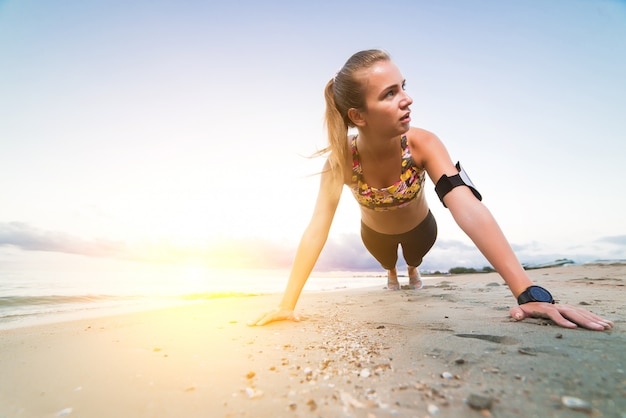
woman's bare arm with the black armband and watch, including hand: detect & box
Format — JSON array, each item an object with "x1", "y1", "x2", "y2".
[{"x1": 412, "y1": 130, "x2": 612, "y2": 330}]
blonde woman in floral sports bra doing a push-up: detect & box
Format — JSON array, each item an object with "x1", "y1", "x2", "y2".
[{"x1": 251, "y1": 50, "x2": 612, "y2": 330}]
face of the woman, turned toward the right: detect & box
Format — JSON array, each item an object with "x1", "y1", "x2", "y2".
[{"x1": 362, "y1": 61, "x2": 413, "y2": 136}]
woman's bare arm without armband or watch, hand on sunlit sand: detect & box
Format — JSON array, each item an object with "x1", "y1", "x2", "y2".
[{"x1": 248, "y1": 162, "x2": 343, "y2": 325}]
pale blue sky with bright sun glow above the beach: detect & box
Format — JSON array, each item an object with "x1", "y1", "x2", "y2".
[{"x1": 0, "y1": 0, "x2": 626, "y2": 270}]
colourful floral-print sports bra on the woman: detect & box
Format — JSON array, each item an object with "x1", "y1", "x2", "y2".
[{"x1": 350, "y1": 135, "x2": 426, "y2": 211}]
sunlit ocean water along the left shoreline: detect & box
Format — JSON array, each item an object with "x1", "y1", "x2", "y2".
[{"x1": 0, "y1": 254, "x2": 386, "y2": 330}]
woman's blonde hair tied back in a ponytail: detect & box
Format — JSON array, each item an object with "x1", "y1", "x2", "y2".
[{"x1": 315, "y1": 49, "x2": 391, "y2": 173}]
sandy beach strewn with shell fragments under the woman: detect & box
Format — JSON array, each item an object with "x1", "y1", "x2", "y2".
[{"x1": 0, "y1": 266, "x2": 626, "y2": 418}]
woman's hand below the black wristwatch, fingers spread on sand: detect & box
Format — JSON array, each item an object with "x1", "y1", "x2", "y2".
[{"x1": 509, "y1": 302, "x2": 613, "y2": 331}]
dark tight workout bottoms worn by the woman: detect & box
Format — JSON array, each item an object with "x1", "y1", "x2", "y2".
[{"x1": 361, "y1": 211, "x2": 437, "y2": 270}]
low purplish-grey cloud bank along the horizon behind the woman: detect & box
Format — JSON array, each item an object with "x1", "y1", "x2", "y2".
[{"x1": 0, "y1": 222, "x2": 626, "y2": 273}]
